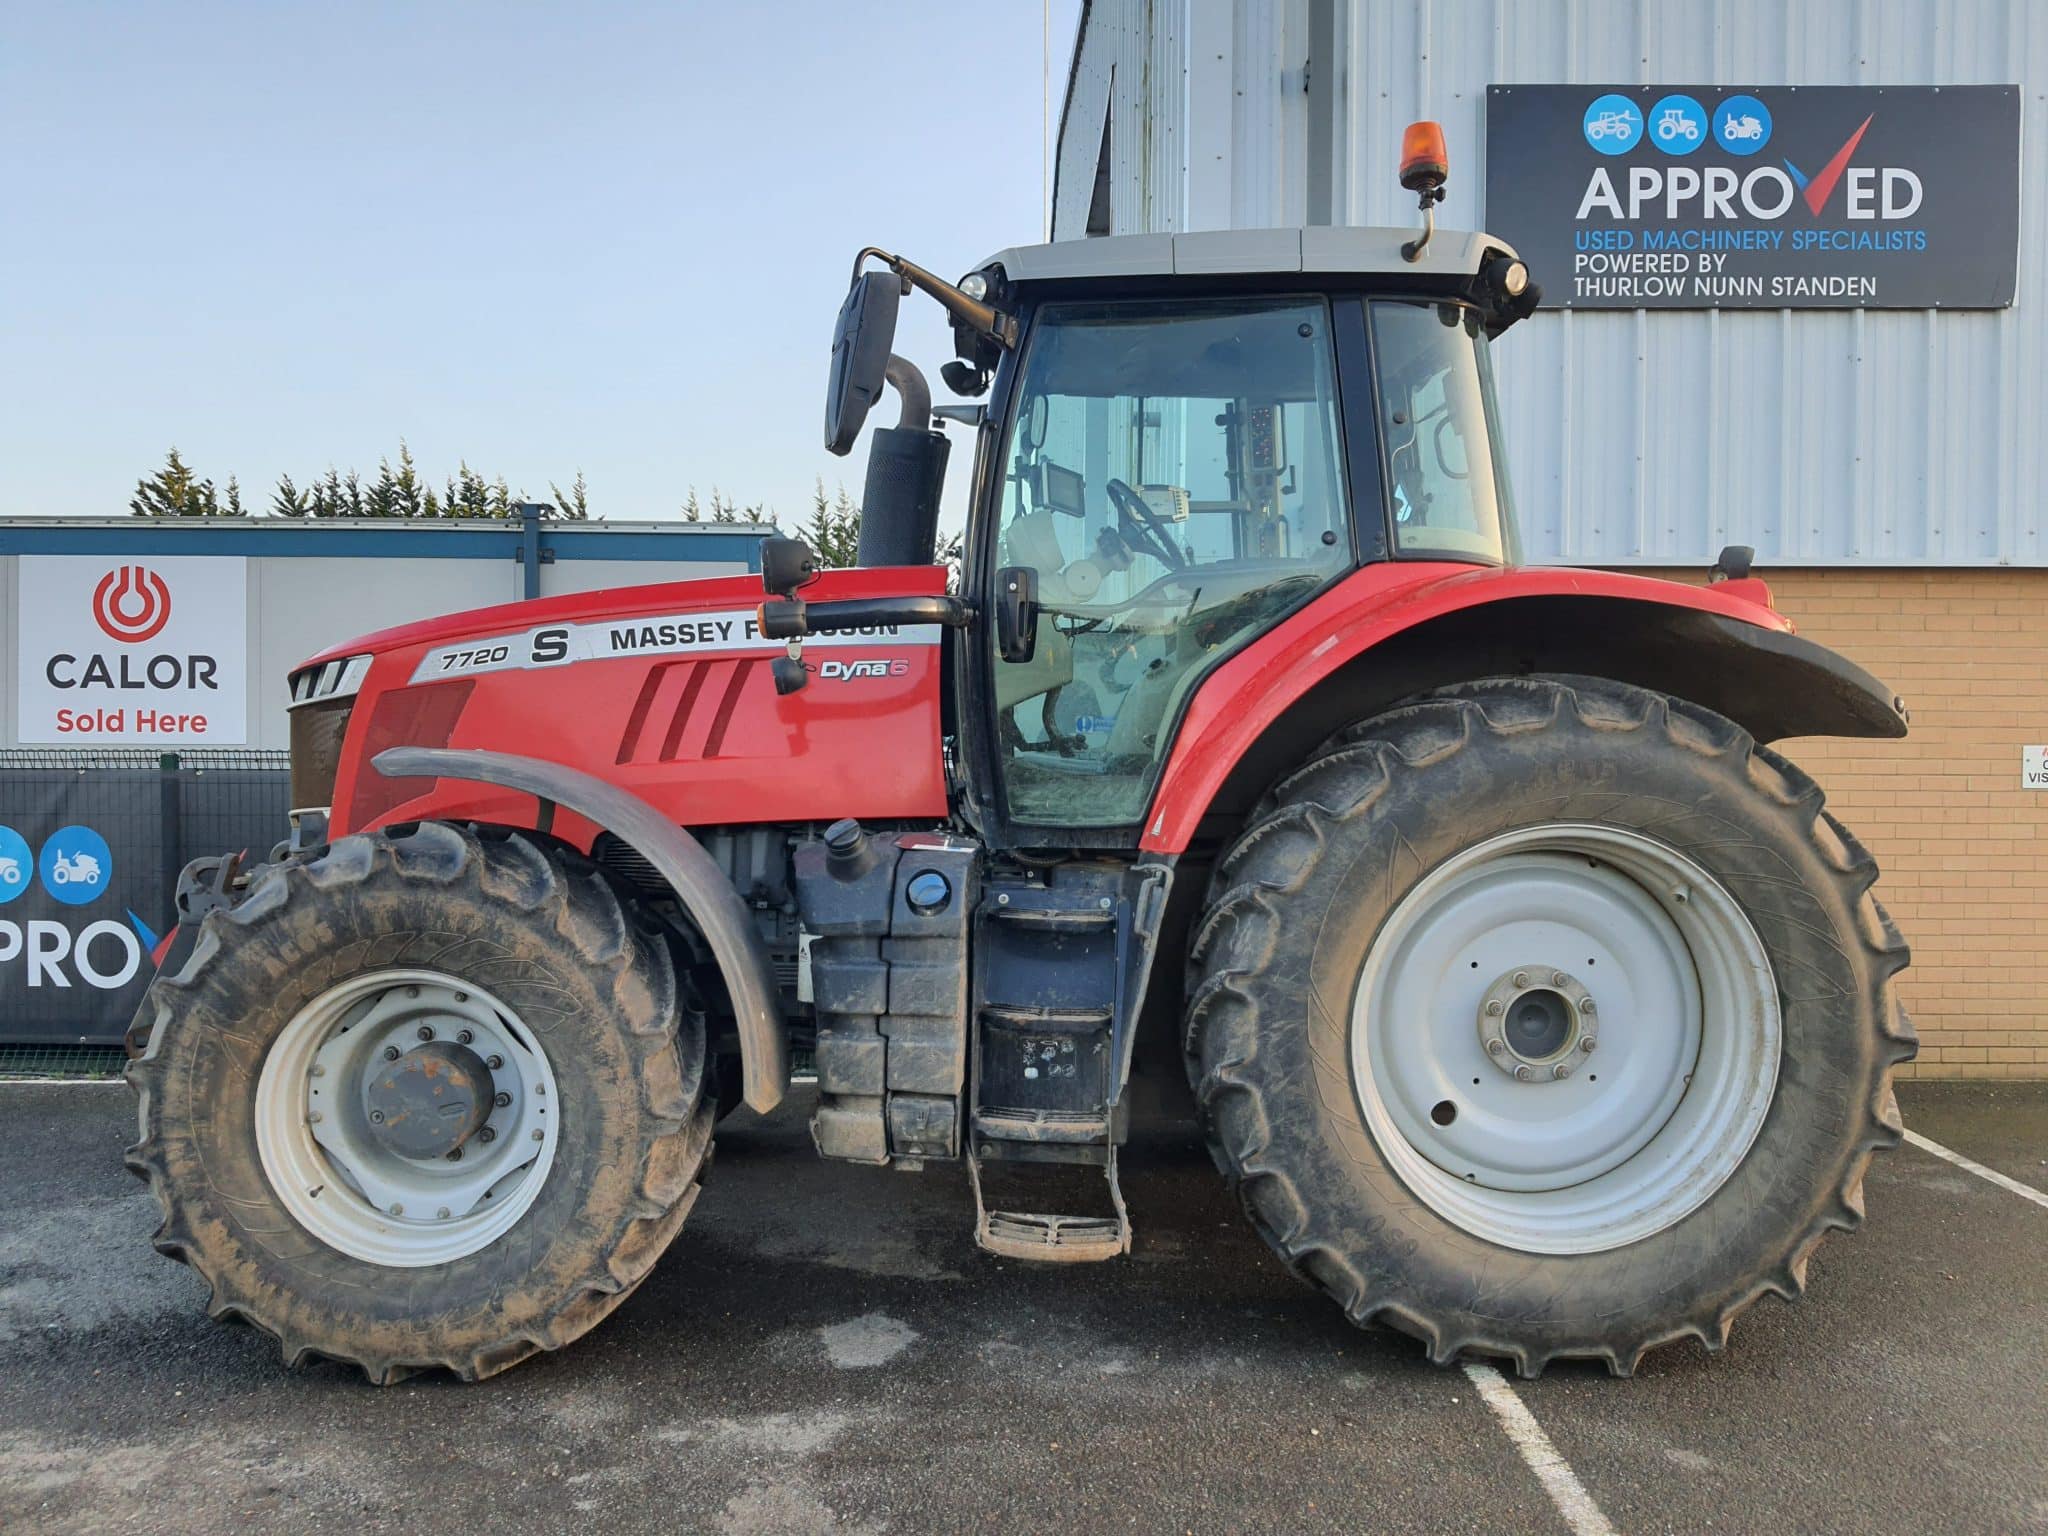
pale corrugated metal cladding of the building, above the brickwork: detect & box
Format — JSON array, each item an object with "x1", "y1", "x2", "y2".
[{"x1": 1055, "y1": 0, "x2": 2048, "y2": 565}]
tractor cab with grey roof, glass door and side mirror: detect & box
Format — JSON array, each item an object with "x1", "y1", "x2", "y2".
[{"x1": 798, "y1": 201, "x2": 1536, "y2": 846}]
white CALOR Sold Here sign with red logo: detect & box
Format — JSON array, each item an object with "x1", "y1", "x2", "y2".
[{"x1": 14, "y1": 555, "x2": 248, "y2": 745}]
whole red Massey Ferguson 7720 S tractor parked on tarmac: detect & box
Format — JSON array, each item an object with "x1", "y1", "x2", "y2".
[{"x1": 129, "y1": 135, "x2": 1913, "y2": 1382}]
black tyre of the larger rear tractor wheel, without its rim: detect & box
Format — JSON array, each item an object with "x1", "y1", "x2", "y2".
[{"x1": 1184, "y1": 678, "x2": 1917, "y2": 1376}]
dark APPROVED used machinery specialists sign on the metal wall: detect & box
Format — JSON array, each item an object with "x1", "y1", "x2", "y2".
[{"x1": 1485, "y1": 86, "x2": 2019, "y2": 309}]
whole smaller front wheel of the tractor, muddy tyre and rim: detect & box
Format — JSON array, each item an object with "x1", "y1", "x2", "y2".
[{"x1": 129, "y1": 823, "x2": 713, "y2": 1382}]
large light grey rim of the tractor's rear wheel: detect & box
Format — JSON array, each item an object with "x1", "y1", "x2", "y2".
[{"x1": 1352, "y1": 823, "x2": 1782, "y2": 1253}]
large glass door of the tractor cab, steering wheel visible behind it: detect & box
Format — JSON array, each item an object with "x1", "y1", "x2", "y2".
[{"x1": 993, "y1": 297, "x2": 1352, "y2": 827}]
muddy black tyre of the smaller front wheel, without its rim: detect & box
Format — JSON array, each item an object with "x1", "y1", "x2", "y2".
[{"x1": 127, "y1": 821, "x2": 713, "y2": 1384}]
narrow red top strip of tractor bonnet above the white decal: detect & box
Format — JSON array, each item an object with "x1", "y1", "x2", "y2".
[{"x1": 293, "y1": 565, "x2": 946, "y2": 672}]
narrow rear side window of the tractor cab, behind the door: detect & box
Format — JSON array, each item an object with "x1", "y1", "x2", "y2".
[{"x1": 1372, "y1": 301, "x2": 1516, "y2": 563}]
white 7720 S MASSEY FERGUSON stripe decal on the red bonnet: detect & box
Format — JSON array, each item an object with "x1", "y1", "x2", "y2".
[{"x1": 412, "y1": 608, "x2": 938, "y2": 682}]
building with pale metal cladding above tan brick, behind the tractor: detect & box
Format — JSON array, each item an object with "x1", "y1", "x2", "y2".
[{"x1": 1053, "y1": 0, "x2": 2048, "y2": 1077}]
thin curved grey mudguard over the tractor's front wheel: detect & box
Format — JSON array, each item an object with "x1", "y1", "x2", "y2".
[{"x1": 375, "y1": 748, "x2": 788, "y2": 1114}]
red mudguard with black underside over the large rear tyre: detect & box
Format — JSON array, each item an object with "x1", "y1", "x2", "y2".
[{"x1": 1141, "y1": 561, "x2": 1907, "y2": 854}]
